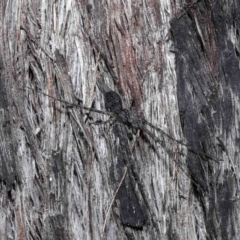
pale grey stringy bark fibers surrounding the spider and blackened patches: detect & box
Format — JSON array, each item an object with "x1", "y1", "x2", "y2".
[{"x1": 0, "y1": 0, "x2": 240, "y2": 240}]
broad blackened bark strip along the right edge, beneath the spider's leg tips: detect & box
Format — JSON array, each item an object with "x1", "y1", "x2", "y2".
[{"x1": 171, "y1": 1, "x2": 240, "y2": 239}]
